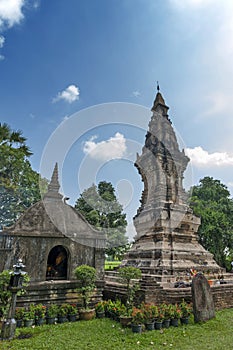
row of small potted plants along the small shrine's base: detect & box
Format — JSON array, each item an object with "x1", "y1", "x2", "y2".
[{"x1": 15, "y1": 303, "x2": 78, "y2": 327}]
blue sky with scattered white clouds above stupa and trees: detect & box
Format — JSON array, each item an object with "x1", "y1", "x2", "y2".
[{"x1": 0, "y1": 0, "x2": 233, "y2": 241}]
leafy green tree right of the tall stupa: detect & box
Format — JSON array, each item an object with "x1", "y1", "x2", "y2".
[{"x1": 191, "y1": 177, "x2": 233, "y2": 268}]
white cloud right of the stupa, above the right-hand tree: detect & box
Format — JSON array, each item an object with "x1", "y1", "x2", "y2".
[{"x1": 185, "y1": 146, "x2": 233, "y2": 168}]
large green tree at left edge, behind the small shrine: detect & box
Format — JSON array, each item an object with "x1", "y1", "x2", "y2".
[{"x1": 0, "y1": 123, "x2": 47, "y2": 228}]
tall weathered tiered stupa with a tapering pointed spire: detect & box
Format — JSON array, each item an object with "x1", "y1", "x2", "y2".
[{"x1": 122, "y1": 87, "x2": 220, "y2": 277}]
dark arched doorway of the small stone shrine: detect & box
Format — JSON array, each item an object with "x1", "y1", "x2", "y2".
[{"x1": 46, "y1": 245, "x2": 68, "y2": 280}]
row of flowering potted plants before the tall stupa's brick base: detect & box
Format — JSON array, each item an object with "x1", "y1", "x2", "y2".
[{"x1": 93, "y1": 300, "x2": 192, "y2": 331}]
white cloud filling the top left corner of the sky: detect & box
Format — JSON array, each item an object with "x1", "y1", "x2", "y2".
[{"x1": 0, "y1": 0, "x2": 26, "y2": 28}]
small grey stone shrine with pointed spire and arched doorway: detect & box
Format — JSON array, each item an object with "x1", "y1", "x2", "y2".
[{"x1": 0, "y1": 164, "x2": 106, "y2": 282}]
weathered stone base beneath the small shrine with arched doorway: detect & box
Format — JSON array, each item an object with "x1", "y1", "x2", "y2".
[{"x1": 17, "y1": 281, "x2": 104, "y2": 306}]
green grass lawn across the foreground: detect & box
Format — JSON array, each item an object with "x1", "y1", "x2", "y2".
[{"x1": 0, "y1": 309, "x2": 233, "y2": 350}]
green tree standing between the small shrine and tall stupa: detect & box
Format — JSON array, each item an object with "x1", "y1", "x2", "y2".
[{"x1": 75, "y1": 181, "x2": 128, "y2": 258}]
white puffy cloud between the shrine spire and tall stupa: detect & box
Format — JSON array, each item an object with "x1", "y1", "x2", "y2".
[{"x1": 83, "y1": 132, "x2": 126, "y2": 161}]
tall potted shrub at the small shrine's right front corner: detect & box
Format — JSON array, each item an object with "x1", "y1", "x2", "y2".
[{"x1": 74, "y1": 265, "x2": 96, "y2": 320}]
